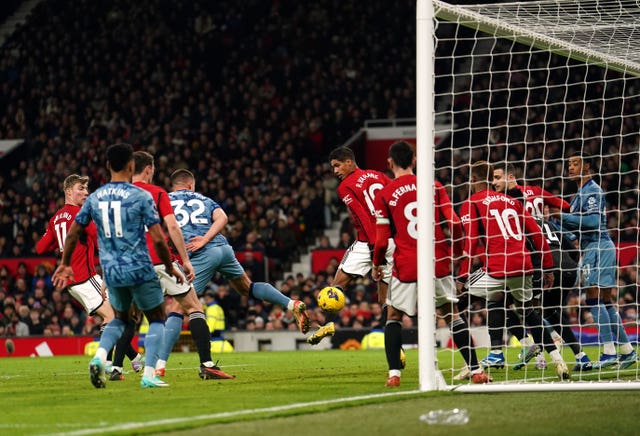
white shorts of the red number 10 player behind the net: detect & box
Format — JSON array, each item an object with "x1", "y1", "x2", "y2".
[{"x1": 465, "y1": 270, "x2": 533, "y2": 302}]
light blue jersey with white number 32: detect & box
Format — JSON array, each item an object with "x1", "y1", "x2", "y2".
[{"x1": 169, "y1": 190, "x2": 227, "y2": 247}]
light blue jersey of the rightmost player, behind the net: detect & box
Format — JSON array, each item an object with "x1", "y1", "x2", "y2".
[{"x1": 562, "y1": 179, "x2": 611, "y2": 248}]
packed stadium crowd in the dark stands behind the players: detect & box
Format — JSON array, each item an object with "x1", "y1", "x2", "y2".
[{"x1": 0, "y1": 0, "x2": 640, "y2": 335}]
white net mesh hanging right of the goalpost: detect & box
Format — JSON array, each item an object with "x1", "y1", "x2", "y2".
[{"x1": 434, "y1": 1, "x2": 640, "y2": 385}]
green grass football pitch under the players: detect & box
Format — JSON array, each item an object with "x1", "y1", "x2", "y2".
[{"x1": 0, "y1": 350, "x2": 640, "y2": 436}]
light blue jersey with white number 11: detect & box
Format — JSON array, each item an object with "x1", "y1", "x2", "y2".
[{"x1": 75, "y1": 182, "x2": 160, "y2": 288}]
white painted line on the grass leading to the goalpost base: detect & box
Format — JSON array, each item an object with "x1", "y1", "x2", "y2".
[{"x1": 47, "y1": 390, "x2": 423, "y2": 436}]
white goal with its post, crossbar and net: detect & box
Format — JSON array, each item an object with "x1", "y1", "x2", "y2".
[{"x1": 416, "y1": 0, "x2": 640, "y2": 392}]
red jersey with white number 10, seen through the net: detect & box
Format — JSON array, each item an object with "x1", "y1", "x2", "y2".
[{"x1": 460, "y1": 190, "x2": 553, "y2": 277}]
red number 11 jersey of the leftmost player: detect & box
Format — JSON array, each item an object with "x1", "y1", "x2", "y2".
[{"x1": 36, "y1": 204, "x2": 98, "y2": 285}]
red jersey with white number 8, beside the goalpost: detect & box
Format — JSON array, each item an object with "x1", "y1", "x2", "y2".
[{"x1": 373, "y1": 174, "x2": 418, "y2": 282}]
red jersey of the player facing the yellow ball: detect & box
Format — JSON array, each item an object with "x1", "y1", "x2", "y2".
[{"x1": 338, "y1": 168, "x2": 389, "y2": 245}]
